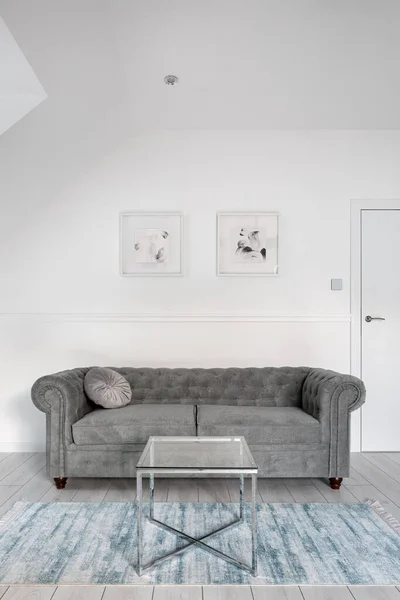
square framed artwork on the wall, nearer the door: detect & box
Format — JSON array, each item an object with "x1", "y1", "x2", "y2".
[{"x1": 217, "y1": 212, "x2": 279, "y2": 277}]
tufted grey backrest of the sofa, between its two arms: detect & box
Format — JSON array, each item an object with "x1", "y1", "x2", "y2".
[{"x1": 113, "y1": 367, "x2": 310, "y2": 406}]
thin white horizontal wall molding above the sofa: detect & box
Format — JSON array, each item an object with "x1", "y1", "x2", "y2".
[{"x1": 0, "y1": 312, "x2": 351, "y2": 323}]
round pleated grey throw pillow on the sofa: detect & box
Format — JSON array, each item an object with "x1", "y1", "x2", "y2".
[{"x1": 83, "y1": 367, "x2": 132, "y2": 408}]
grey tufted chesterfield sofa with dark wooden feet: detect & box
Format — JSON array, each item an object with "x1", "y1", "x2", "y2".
[{"x1": 32, "y1": 367, "x2": 365, "y2": 489}]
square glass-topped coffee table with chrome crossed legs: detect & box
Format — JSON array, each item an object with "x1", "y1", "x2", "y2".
[{"x1": 136, "y1": 436, "x2": 258, "y2": 576}]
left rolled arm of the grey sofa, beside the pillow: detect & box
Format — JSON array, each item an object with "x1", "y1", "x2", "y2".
[{"x1": 31, "y1": 368, "x2": 92, "y2": 477}]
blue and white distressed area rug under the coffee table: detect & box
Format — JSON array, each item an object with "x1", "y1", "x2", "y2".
[{"x1": 0, "y1": 502, "x2": 400, "y2": 585}]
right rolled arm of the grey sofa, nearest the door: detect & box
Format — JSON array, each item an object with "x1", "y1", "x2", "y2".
[{"x1": 302, "y1": 369, "x2": 365, "y2": 477}]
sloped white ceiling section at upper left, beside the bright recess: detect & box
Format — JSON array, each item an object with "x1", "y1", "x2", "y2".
[{"x1": 0, "y1": 0, "x2": 132, "y2": 241}]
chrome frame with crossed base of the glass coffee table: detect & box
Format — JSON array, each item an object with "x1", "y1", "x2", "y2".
[{"x1": 136, "y1": 436, "x2": 257, "y2": 577}]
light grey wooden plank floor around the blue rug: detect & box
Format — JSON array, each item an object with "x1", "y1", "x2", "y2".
[{"x1": 0, "y1": 453, "x2": 400, "y2": 600}]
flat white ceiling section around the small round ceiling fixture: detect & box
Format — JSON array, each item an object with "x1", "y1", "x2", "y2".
[{"x1": 113, "y1": 0, "x2": 400, "y2": 128}]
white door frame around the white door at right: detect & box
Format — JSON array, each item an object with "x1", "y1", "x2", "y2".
[{"x1": 350, "y1": 198, "x2": 400, "y2": 452}]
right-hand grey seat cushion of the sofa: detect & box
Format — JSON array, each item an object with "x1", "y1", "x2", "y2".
[{"x1": 197, "y1": 405, "x2": 321, "y2": 445}]
